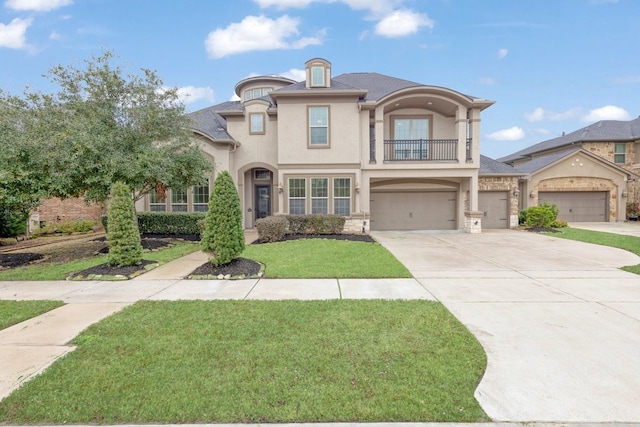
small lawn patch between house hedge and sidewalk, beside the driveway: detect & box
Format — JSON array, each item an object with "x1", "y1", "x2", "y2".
[{"x1": 242, "y1": 239, "x2": 412, "y2": 279}]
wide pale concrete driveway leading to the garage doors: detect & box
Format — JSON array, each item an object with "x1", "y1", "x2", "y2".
[{"x1": 372, "y1": 229, "x2": 640, "y2": 423}]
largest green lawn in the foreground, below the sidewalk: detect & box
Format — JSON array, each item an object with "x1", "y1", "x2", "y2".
[{"x1": 0, "y1": 300, "x2": 488, "y2": 425}]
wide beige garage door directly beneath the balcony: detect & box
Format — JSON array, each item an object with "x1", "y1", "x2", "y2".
[{"x1": 371, "y1": 191, "x2": 456, "y2": 230}]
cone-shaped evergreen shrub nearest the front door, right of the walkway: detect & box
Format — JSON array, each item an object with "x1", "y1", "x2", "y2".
[{"x1": 200, "y1": 171, "x2": 244, "y2": 265}]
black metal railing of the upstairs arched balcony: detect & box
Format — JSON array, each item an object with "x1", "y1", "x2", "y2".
[{"x1": 384, "y1": 139, "x2": 462, "y2": 162}]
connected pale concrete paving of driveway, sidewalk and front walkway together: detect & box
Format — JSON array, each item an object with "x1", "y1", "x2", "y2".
[{"x1": 0, "y1": 225, "x2": 640, "y2": 427}]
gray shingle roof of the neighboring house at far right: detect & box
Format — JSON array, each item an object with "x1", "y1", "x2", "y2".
[{"x1": 498, "y1": 117, "x2": 640, "y2": 162}]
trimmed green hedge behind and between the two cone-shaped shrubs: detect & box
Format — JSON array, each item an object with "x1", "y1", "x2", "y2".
[{"x1": 102, "y1": 212, "x2": 206, "y2": 235}]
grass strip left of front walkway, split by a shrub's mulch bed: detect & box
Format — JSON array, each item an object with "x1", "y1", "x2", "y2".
[{"x1": 0, "y1": 243, "x2": 200, "y2": 280}]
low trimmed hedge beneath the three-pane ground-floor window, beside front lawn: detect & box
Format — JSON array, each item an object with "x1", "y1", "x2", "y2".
[{"x1": 256, "y1": 214, "x2": 346, "y2": 243}]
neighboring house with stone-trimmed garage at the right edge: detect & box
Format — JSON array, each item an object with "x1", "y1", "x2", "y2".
[{"x1": 499, "y1": 118, "x2": 640, "y2": 222}]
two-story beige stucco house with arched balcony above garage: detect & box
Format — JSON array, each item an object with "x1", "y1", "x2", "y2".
[{"x1": 137, "y1": 59, "x2": 496, "y2": 232}]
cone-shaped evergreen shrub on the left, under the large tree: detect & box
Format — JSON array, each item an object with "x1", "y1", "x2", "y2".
[{"x1": 107, "y1": 182, "x2": 142, "y2": 267}]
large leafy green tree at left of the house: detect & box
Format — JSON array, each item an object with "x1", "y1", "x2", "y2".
[{"x1": 0, "y1": 51, "x2": 211, "y2": 206}]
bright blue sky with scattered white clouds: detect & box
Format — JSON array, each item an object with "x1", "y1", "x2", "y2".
[{"x1": 0, "y1": 0, "x2": 640, "y2": 158}]
